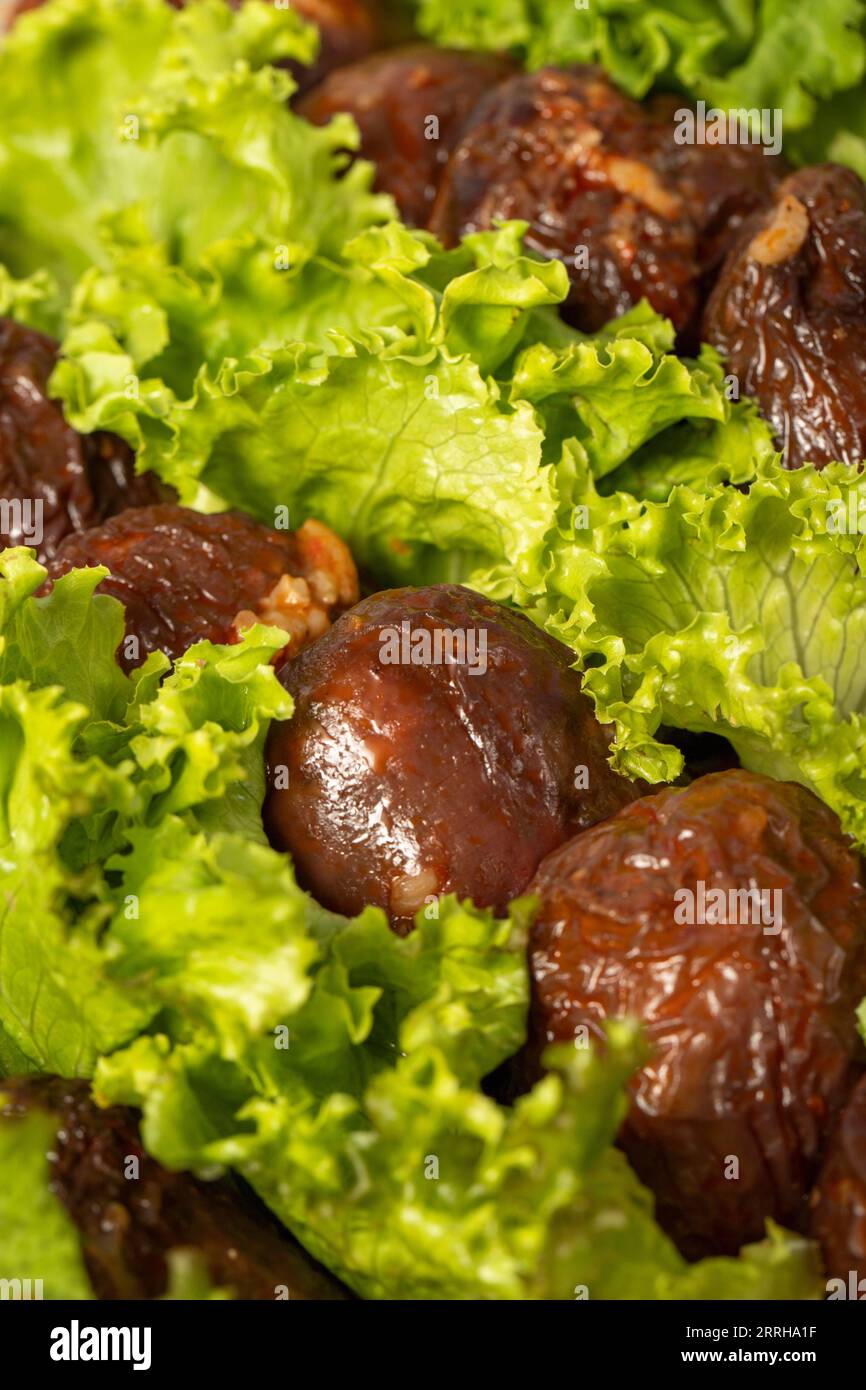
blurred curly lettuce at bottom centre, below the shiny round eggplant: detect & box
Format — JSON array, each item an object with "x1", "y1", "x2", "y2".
[{"x1": 96, "y1": 856, "x2": 817, "y2": 1298}]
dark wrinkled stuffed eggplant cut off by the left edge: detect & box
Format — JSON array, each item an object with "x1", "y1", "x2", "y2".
[{"x1": 0, "y1": 318, "x2": 168, "y2": 562}]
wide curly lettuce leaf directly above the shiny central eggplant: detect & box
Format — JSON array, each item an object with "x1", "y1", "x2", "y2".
[{"x1": 53, "y1": 222, "x2": 756, "y2": 582}]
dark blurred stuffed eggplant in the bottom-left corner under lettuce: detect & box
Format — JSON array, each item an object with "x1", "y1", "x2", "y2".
[{"x1": 0, "y1": 1076, "x2": 350, "y2": 1301}]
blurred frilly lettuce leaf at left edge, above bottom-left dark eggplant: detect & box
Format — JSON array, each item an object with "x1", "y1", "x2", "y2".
[{"x1": 0, "y1": 647, "x2": 149, "y2": 1074}]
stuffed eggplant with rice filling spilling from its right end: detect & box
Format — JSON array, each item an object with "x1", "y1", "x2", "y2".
[{"x1": 49, "y1": 505, "x2": 357, "y2": 670}]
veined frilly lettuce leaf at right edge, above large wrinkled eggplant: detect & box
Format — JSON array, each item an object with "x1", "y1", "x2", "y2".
[{"x1": 480, "y1": 459, "x2": 866, "y2": 844}]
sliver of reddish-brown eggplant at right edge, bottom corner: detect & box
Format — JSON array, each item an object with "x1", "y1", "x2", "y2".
[{"x1": 812, "y1": 1079, "x2": 866, "y2": 1298}]
